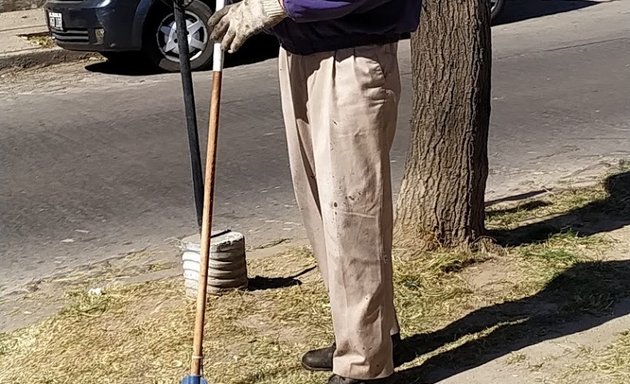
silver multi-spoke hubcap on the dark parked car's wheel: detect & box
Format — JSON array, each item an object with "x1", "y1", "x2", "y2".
[{"x1": 156, "y1": 12, "x2": 208, "y2": 62}]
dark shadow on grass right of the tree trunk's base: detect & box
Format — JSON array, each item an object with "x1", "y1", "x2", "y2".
[{"x1": 490, "y1": 172, "x2": 630, "y2": 246}]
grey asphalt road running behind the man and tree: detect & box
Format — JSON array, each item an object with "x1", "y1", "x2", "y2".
[{"x1": 0, "y1": 0, "x2": 630, "y2": 295}]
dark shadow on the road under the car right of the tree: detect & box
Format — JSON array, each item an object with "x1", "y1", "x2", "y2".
[{"x1": 494, "y1": 0, "x2": 599, "y2": 25}]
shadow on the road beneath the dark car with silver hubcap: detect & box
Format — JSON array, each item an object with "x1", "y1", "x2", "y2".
[{"x1": 85, "y1": 35, "x2": 279, "y2": 76}]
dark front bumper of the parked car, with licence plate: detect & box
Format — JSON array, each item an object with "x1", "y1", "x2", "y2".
[{"x1": 44, "y1": 0, "x2": 141, "y2": 52}]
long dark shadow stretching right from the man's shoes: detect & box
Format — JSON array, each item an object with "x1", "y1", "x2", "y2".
[{"x1": 396, "y1": 261, "x2": 630, "y2": 384}]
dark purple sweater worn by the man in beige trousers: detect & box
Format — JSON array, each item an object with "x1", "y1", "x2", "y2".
[{"x1": 272, "y1": 0, "x2": 422, "y2": 55}]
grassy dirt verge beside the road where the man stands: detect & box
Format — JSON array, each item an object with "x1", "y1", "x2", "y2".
[{"x1": 0, "y1": 170, "x2": 630, "y2": 384}]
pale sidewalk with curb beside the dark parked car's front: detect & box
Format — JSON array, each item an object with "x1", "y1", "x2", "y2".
[{"x1": 0, "y1": 8, "x2": 94, "y2": 71}]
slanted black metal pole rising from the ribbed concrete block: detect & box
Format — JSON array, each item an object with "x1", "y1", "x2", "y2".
[{"x1": 173, "y1": 0, "x2": 203, "y2": 228}]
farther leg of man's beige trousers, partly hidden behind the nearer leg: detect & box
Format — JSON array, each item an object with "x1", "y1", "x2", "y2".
[{"x1": 278, "y1": 49, "x2": 328, "y2": 287}]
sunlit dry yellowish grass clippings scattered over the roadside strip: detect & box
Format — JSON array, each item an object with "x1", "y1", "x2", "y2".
[{"x1": 0, "y1": 170, "x2": 630, "y2": 384}]
